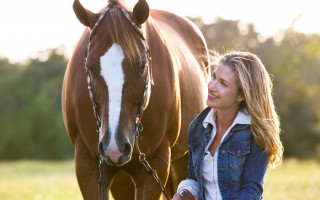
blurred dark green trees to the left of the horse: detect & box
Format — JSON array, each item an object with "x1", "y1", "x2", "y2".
[{"x1": 0, "y1": 50, "x2": 72, "y2": 159}]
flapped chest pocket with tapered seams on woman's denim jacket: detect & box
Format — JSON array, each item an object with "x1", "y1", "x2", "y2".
[{"x1": 227, "y1": 141, "x2": 250, "y2": 191}]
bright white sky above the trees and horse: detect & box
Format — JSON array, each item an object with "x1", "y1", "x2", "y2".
[{"x1": 0, "y1": 0, "x2": 320, "y2": 62}]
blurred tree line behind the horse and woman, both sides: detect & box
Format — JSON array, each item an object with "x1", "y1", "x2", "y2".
[{"x1": 0, "y1": 18, "x2": 320, "y2": 160}]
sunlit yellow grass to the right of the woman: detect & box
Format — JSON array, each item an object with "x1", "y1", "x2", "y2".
[{"x1": 264, "y1": 160, "x2": 320, "y2": 200}]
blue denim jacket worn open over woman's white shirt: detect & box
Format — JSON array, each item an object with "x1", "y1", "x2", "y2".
[{"x1": 188, "y1": 108, "x2": 269, "y2": 200}]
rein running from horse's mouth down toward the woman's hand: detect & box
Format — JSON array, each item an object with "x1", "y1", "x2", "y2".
[{"x1": 135, "y1": 115, "x2": 170, "y2": 200}]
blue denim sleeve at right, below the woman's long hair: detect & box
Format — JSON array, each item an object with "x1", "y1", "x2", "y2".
[{"x1": 232, "y1": 139, "x2": 269, "y2": 200}]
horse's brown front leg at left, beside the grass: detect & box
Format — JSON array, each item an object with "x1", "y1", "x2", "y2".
[{"x1": 75, "y1": 138, "x2": 104, "y2": 200}]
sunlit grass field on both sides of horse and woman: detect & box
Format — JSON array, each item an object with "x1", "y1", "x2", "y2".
[{"x1": 0, "y1": 160, "x2": 320, "y2": 200}]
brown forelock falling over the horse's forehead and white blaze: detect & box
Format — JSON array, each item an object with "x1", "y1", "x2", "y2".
[{"x1": 105, "y1": 5, "x2": 141, "y2": 63}]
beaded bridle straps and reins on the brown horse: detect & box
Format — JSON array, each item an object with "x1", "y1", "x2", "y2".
[{"x1": 85, "y1": 3, "x2": 170, "y2": 200}]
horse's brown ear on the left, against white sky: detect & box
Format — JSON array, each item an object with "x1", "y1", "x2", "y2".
[{"x1": 73, "y1": 0, "x2": 99, "y2": 28}]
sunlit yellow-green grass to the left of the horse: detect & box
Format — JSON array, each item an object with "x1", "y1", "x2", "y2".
[{"x1": 0, "y1": 161, "x2": 82, "y2": 200}]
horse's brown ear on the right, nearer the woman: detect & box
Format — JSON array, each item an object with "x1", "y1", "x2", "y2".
[{"x1": 132, "y1": 0, "x2": 149, "y2": 25}]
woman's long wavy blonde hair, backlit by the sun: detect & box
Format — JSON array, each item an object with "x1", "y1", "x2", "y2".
[{"x1": 211, "y1": 51, "x2": 283, "y2": 167}]
